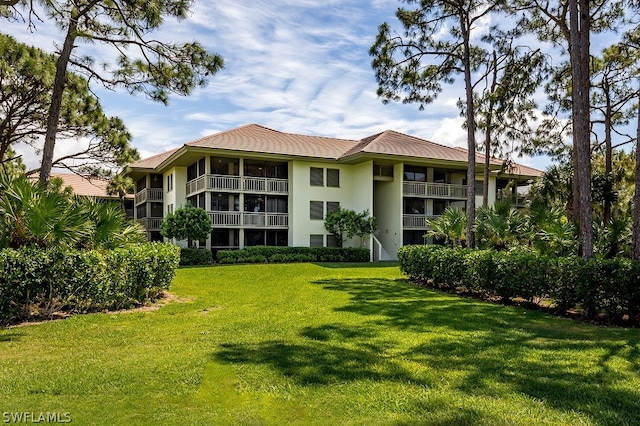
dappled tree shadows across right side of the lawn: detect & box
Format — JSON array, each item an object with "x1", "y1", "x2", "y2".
[{"x1": 213, "y1": 279, "x2": 640, "y2": 425}]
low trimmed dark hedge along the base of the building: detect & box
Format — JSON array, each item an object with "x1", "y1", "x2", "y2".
[{"x1": 217, "y1": 246, "x2": 370, "y2": 263}]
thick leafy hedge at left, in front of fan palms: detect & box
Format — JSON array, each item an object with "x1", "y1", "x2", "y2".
[{"x1": 0, "y1": 243, "x2": 180, "y2": 323}]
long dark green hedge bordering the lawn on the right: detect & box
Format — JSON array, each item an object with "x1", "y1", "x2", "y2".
[{"x1": 398, "y1": 245, "x2": 640, "y2": 319}]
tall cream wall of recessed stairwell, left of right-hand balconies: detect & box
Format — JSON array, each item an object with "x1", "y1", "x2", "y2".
[{"x1": 373, "y1": 164, "x2": 402, "y2": 260}]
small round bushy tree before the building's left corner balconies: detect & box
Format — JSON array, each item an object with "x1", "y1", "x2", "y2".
[{"x1": 160, "y1": 204, "x2": 211, "y2": 245}]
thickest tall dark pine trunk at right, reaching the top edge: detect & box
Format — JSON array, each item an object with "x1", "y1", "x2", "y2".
[{"x1": 569, "y1": 0, "x2": 593, "y2": 259}]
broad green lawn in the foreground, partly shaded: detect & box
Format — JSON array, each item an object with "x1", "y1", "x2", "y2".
[{"x1": 0, "y1": 264, "x2": 640, "y2": 425}]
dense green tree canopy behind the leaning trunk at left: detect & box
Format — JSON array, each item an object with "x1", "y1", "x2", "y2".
[{"x1": 0, "y1": 34, "x2": 139, "y2": 175}]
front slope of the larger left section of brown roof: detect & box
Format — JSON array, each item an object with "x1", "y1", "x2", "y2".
[{"x1": 186, "y1": 124, "x2": 358, "y2": 160}]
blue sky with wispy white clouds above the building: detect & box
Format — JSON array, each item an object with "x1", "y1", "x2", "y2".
[{"x1": 2, "y1": 0, "x2": 549, "y2": 169}]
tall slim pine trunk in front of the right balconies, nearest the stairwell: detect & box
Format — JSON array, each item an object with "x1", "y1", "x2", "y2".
[{"x1": 460, "y1": 13, "x2": 476, "y2": 248}]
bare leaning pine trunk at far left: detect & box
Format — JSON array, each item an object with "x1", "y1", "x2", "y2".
[{"x1": 40, "y1": 14, "x2": 77, "y2": 184}]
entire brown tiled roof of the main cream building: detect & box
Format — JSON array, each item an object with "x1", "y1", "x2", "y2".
[{"x1": 130, "y1": 123, "x2": 542, "y2": 177}]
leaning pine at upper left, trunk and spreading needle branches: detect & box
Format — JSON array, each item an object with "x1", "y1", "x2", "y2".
[{"x1": 0, "y1": 0, "x2": 223, "y2": 182}]
